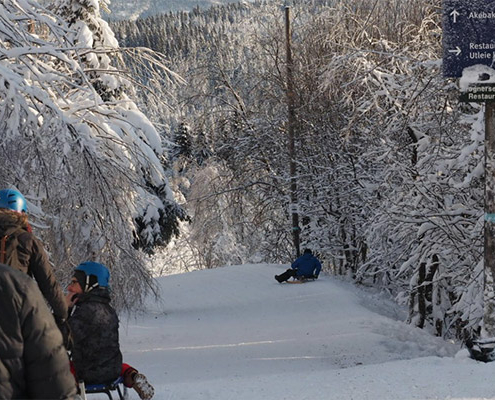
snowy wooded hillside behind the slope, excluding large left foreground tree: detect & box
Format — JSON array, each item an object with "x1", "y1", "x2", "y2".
[{"x1": 112, "y1": 0, "x2": 492, "y2": 337}]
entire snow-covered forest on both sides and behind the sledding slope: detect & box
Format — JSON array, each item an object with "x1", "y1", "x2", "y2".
[{"x1": 0, "y1": 0, "x2": 492, "y2": 338}]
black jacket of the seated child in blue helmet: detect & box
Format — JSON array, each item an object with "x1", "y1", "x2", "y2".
[{"x1": 68, "y1": 288, "x2": 122, "y2": 384}]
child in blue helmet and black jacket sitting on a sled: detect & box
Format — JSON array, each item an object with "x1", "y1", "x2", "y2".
[{"x1": 66, "y1": 261, "x2": 154, "y2": 399}]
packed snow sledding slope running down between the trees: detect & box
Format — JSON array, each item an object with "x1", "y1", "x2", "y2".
[{"x1": 114, "y1": 265, "x2": 495, "y2": 400}]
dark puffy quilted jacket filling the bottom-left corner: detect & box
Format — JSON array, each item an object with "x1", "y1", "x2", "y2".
[{"x1": 0, "y1": 264, "x2": 76, "y2": 399}]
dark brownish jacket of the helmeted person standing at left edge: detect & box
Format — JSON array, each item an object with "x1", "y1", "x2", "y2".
[{"x1": 0, "y1": 209, "x2": 67, "y2": 321}]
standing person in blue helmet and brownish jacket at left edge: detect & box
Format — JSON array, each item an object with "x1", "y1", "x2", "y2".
[{"x1": 0, "y1": 189, "x2": 68, "y2": 332}]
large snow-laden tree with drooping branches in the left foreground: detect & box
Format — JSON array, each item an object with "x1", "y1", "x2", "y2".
[{"x1": 0, "y1": 0, "x2": 184, "y2": 306}]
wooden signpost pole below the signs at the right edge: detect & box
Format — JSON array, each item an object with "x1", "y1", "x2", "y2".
[{"x1": 484, "y1": 101, "x2": 495, "y2": 288}]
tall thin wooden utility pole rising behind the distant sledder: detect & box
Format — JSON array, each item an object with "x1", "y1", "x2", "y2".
[{"x1": 285, "y1": 6, "x2": 301, "y2": 257}]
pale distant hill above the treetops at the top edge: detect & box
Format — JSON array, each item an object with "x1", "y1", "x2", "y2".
[{"x1": 104, "y1": 0, "x2": 252, "y2": 20}]
